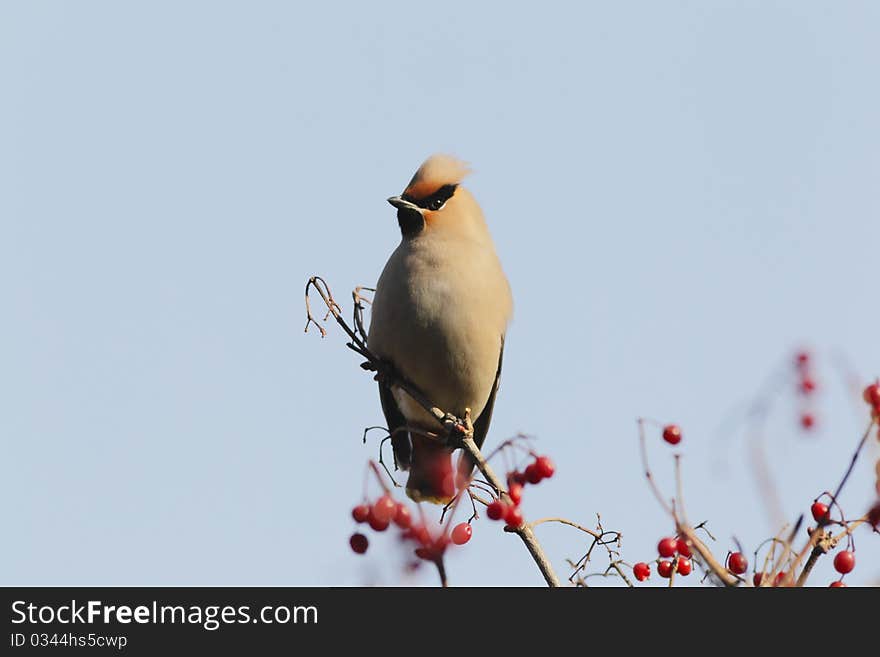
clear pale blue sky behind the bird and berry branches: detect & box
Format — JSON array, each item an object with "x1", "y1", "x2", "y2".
[{"x1": 0, "y1": 1, "x2": 880, "y2": 585}]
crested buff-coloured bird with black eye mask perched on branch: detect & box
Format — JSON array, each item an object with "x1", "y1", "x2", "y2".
[{"x1": 367, "y1": 154, "x2": 513, "y2": 504}]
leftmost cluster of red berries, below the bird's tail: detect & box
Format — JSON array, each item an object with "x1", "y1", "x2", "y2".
[{"x1": 349, "y1": 493, "x2": 472, "y2": 561}]
